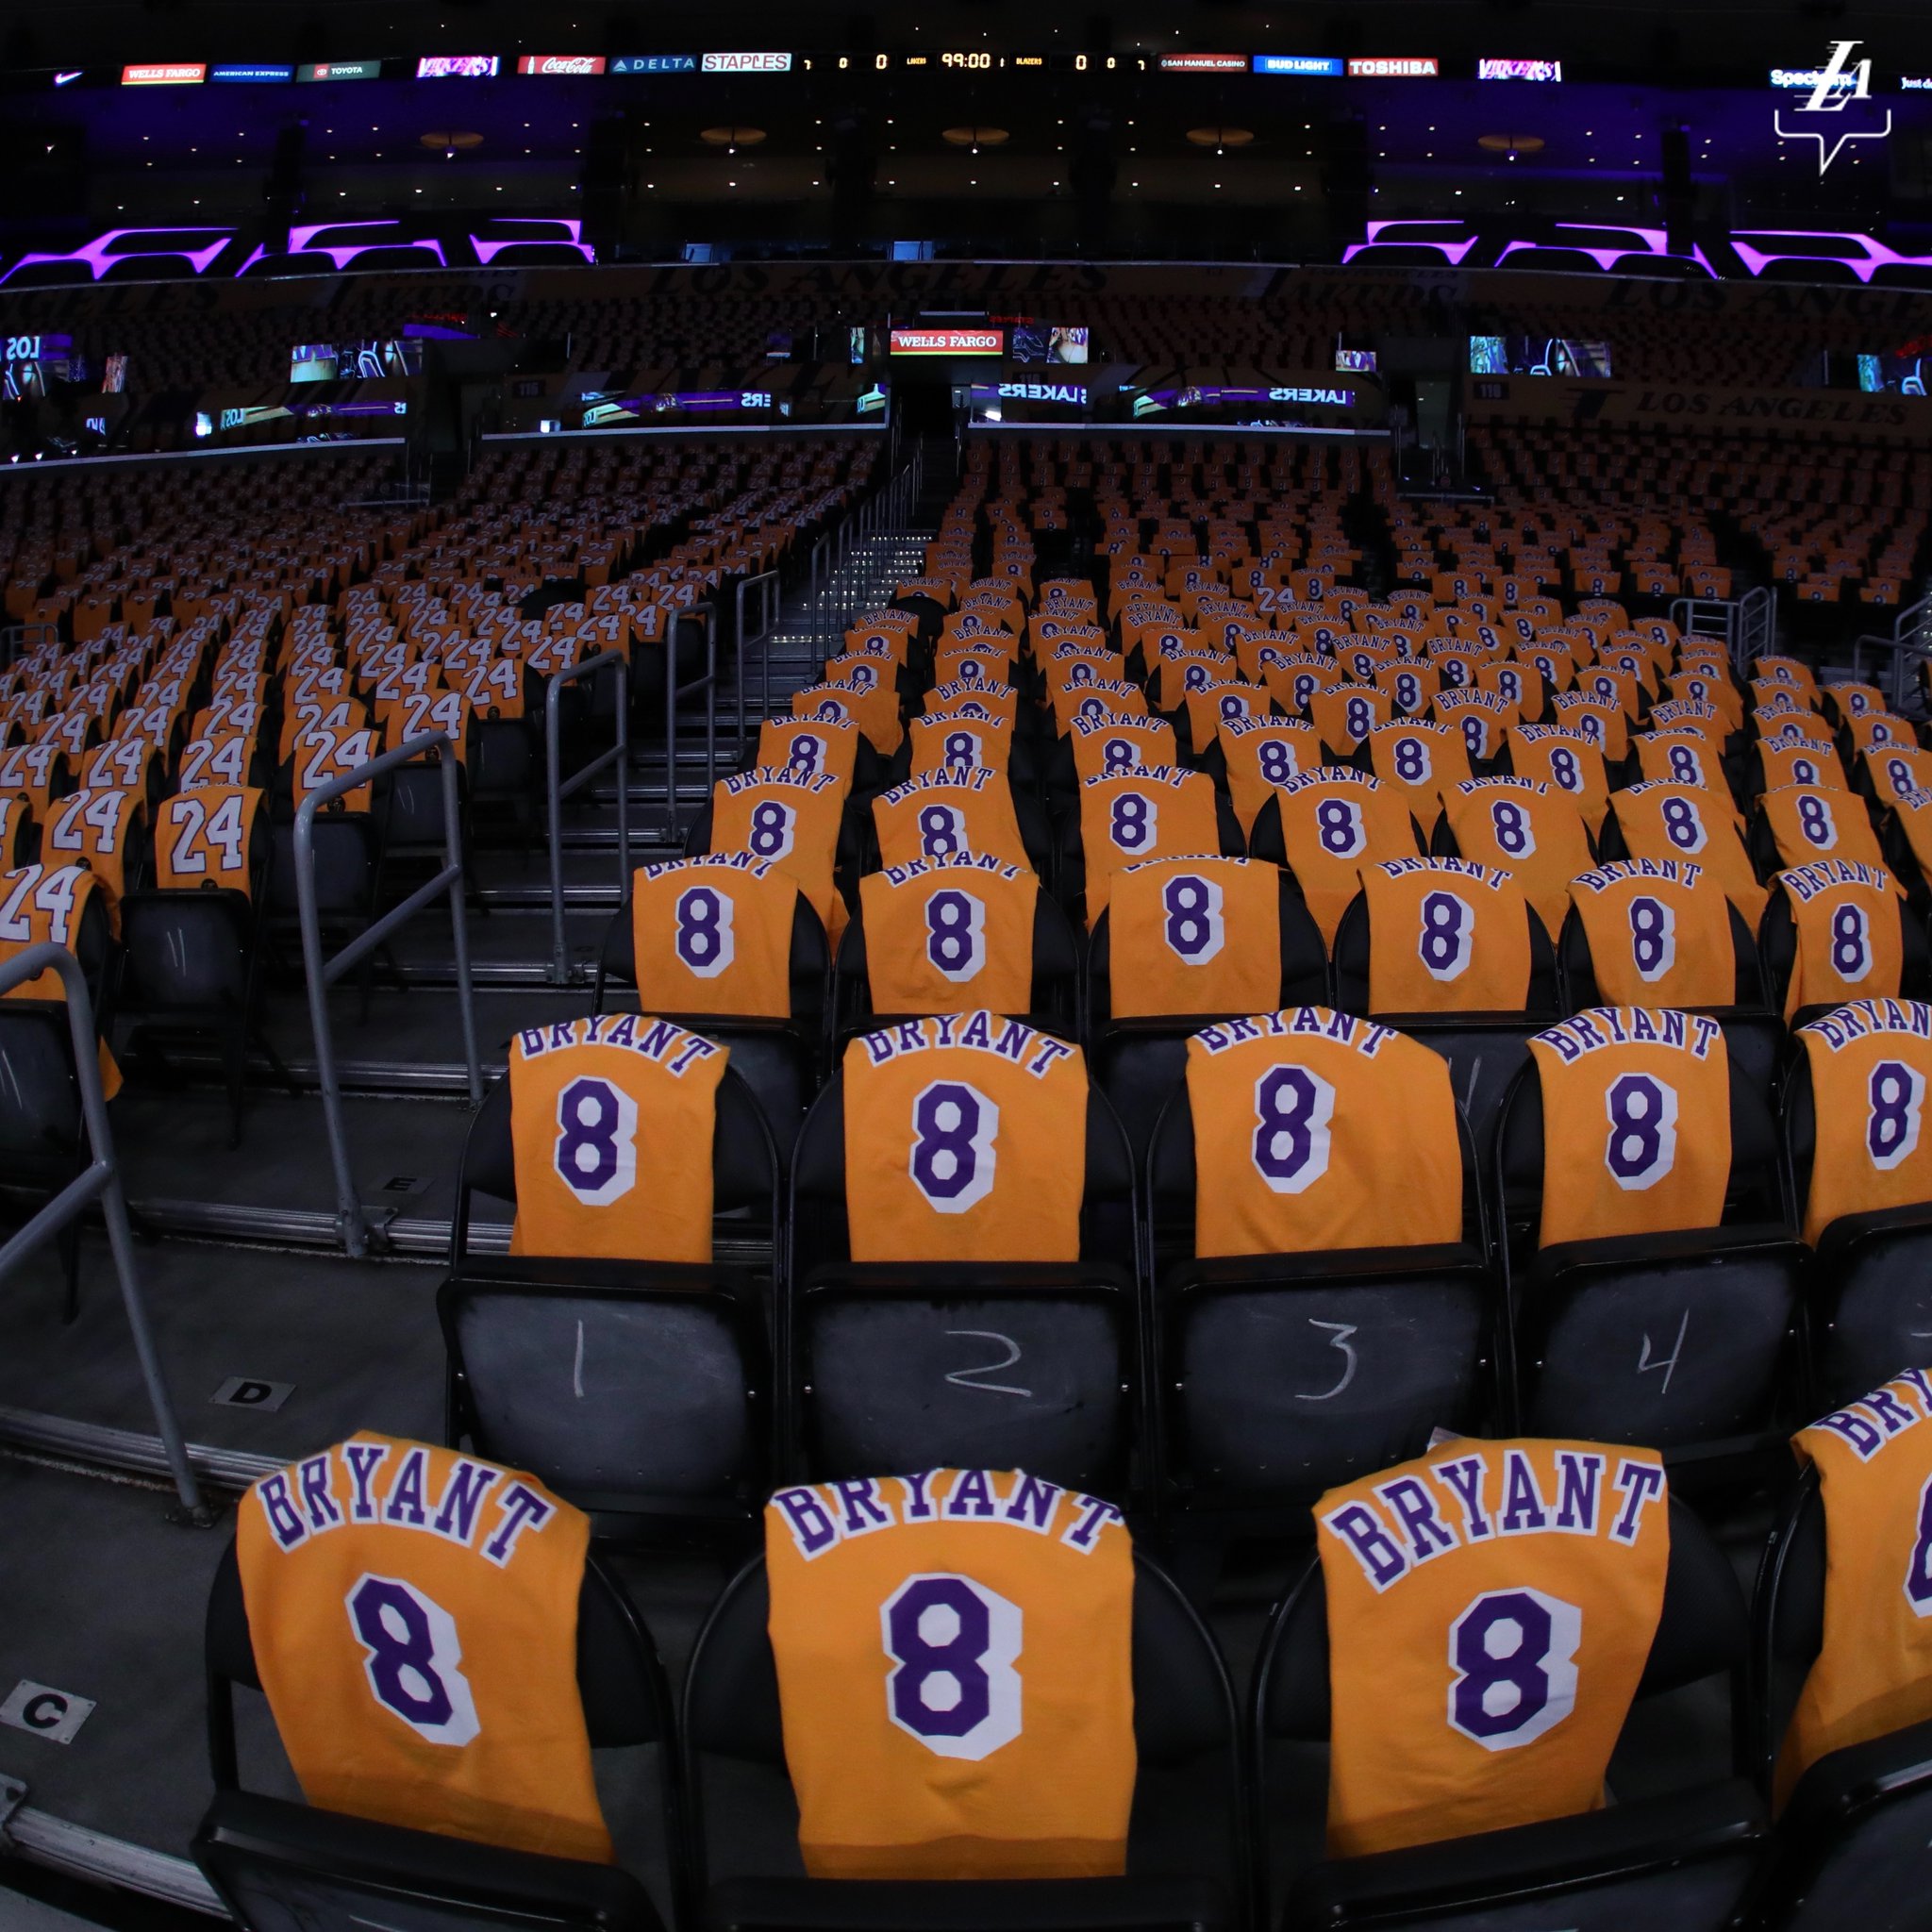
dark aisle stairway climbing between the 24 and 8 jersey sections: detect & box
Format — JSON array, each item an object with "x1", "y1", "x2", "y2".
[{"x1": 0, "y1": 444, "x2": 953, "y2": 1921}]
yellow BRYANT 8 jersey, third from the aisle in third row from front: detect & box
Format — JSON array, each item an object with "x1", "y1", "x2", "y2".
[{"x1": 1108, "y1": 854, "x2": 1281, "y2": 1020}]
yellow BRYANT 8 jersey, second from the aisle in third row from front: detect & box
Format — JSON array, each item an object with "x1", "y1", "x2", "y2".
[{"x1": 858, "y1": 852, "x2": 1040, "y2": 1012}]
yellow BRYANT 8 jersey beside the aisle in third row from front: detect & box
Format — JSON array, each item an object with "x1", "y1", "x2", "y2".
[{"x1": 630, "y1": 852, "x2": 798, "y2": 1020}]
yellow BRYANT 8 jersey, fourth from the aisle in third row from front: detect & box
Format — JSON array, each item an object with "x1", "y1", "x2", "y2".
[{"x1": 1362, "y1": 858, "x2": 1534, "y2": 1012}]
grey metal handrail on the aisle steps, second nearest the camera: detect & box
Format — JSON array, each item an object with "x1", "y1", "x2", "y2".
[{"x1": 295, "y1": 730, "x2": 483, "y2": 1259}]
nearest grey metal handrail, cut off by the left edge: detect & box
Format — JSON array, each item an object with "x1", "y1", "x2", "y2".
[{"x1": 0, "y1": 941, "x2": 214, "y2": 1526}]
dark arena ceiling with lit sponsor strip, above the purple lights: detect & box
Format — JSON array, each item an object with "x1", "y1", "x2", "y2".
[{"x1": 0, "y1": 0, "x2": 1932, "y2": 258}]
